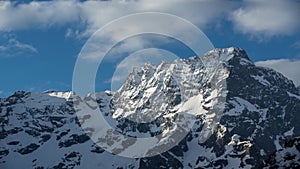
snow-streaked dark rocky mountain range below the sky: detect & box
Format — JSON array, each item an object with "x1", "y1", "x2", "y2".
[{"x1": 0, "y1": 48, "x2": 300, "y2": 168}]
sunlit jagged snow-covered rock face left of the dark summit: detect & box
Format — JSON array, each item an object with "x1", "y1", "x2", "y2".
[{"x1": 112, "y1": 47, "x2": 229, "y2": 141}]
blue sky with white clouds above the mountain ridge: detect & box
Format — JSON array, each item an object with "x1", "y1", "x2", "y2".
[{"x1": 0, "y1": 0, "x2": 300, "y2": 97}]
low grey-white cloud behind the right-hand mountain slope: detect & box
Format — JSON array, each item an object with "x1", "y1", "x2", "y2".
[{"x1": 255, "y1": 59, "x2": 300, "y2": 86}]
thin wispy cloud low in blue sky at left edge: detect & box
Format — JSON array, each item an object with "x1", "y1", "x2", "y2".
[{"x1": 0, "y1": 35, "x2": 38, "y2": 57}]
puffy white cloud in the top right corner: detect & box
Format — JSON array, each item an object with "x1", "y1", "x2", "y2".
[{"x1": 230, "y1": 0, "x2": 300, "y2": 37}]
